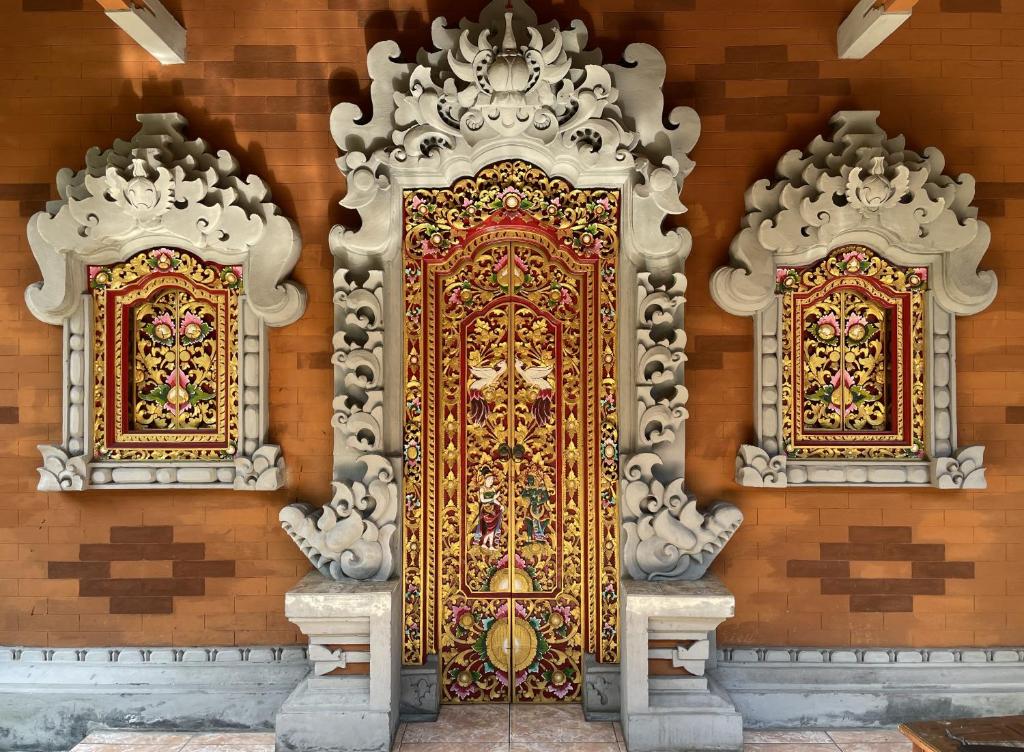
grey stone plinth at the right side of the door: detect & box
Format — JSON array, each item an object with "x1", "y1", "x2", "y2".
[{"x1": 622, "y1": 575, "x2": 743, "y2": 752}]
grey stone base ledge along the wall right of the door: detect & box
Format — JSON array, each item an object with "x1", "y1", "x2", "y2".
[{"x1": 716, "y1": 647, "x2": 1024, "y2": 728}]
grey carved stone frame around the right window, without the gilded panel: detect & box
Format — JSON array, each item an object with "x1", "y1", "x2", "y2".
[{"x1": 711, "y1": 111, "x2": 996, "y2": 489}]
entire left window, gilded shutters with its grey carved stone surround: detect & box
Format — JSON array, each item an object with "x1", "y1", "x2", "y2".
[{"x1": 26, "y1": 114, "x2": 305, "y2": 491}]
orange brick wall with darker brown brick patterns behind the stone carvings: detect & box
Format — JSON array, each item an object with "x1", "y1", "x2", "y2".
[{"x1": 0, "y1": 0, "x2": 1024, "y2": 645}]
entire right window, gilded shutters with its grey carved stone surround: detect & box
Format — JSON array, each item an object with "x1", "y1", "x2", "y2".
[{"x1": 712, "y1": 112, "x2": 996, "y2": 488}]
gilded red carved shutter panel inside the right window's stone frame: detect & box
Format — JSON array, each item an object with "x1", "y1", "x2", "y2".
[{"x1": 776, "y1": 246, "x2": 928, "y2": 459}]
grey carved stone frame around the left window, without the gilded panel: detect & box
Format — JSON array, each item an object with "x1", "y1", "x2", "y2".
[{"x1": 26, "y1": 113, "x2": 306, "y2": 491}]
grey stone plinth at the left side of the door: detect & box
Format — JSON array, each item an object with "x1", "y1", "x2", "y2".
[{"x1": 276, "y1": 572, "x2": 401, "y2": 752}]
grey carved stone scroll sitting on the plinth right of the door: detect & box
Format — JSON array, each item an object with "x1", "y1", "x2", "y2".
[{"x1": 623, "y1": 453, "x2": 743, "y2": 580}]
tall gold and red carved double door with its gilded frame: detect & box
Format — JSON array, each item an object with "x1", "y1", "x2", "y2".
[{"x1": 403, "y1": 162, "x2": 618, "y2": 702}]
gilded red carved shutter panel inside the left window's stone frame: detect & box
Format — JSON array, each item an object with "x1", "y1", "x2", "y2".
[{"x1": 89, "y1": 248, "x2": 242, "y2": 461}]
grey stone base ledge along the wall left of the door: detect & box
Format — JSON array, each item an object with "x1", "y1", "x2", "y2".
[{"x1": 0, "y1": 646, "x2": 309, "y2": 752}]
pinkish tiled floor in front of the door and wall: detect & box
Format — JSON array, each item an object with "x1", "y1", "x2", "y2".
[{"x1": 72, "y1": 705, "x2": 911, "y2": 752}]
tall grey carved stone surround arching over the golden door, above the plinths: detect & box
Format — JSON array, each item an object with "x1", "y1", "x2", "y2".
[{"x1": 281, "y1": 0, "x2": 741, "y2": 579}]
